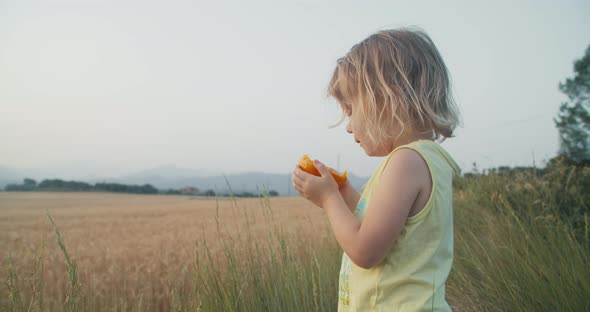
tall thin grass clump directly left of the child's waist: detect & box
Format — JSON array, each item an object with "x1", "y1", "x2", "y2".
[{"x1": 191, "y1": 189, "x2": 340, "y2": 311}]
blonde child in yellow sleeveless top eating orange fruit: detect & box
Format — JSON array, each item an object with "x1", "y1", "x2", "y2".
[{"x1": 293, "y1": 29, "x2": 459, "y2": 311}]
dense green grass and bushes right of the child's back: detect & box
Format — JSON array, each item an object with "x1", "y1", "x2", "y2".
[{"x1": 447, "y1": 164, "x2": 590, "y2": 311}]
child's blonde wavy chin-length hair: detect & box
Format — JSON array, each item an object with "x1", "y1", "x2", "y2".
[{"x1": 328, "y1": 28, "x2": 461, "y2": 142}]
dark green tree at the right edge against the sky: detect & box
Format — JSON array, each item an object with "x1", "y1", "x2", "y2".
[{"x1": 554, "y1": 46, "x2": 590, "y2": 164}]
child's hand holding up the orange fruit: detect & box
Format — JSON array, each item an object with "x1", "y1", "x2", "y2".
[{"x1": 293, "y1": 160, "x2": 341, "y2": 208}]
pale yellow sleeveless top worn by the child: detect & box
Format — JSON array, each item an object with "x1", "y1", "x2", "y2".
[{"x1": 338, "y1": 140, "x2": 460, "y2": 311}]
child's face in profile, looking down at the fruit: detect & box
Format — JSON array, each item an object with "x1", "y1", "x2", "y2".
[{"x1": 342, "y1": 105, "x2": 393, "y2": 156}]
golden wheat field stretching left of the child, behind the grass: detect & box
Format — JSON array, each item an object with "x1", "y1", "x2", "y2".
[{"x1": 0, "y1": 192, "x2": 329, "y2": 308}]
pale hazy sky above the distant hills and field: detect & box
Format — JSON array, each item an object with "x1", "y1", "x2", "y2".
[{"x1": 0, "y1": 0, "x2": 590, "y2": 176}]
